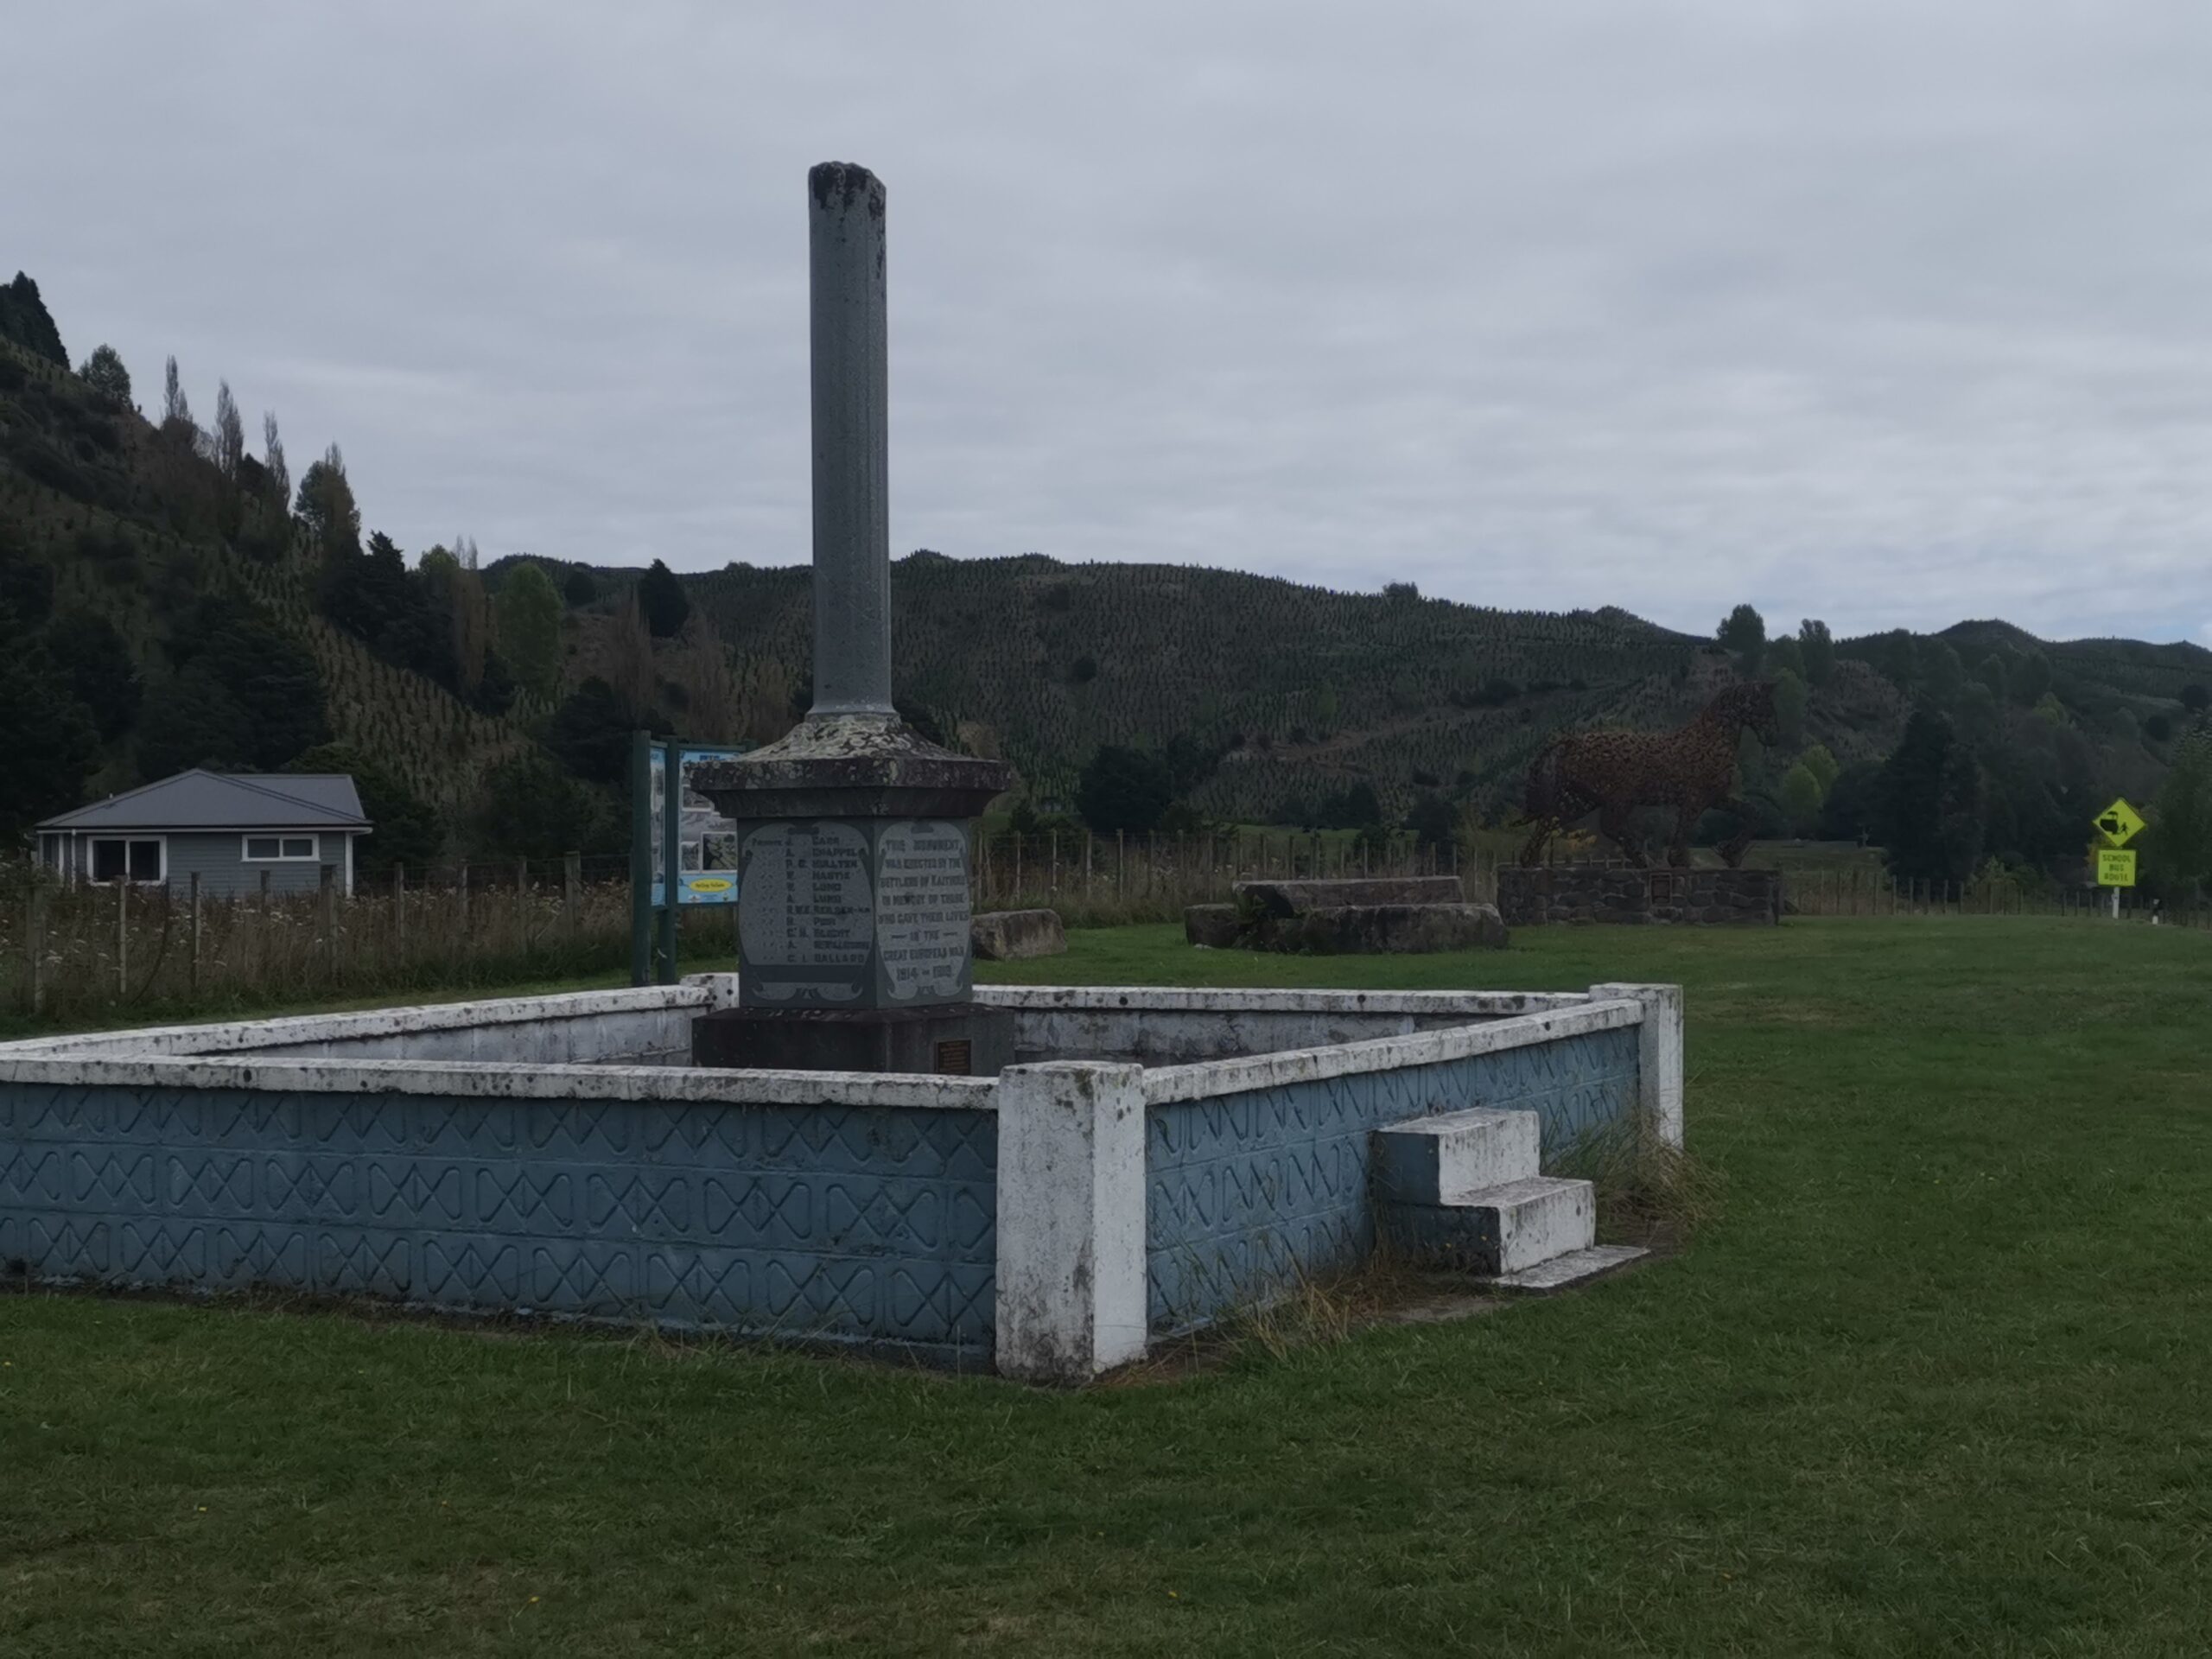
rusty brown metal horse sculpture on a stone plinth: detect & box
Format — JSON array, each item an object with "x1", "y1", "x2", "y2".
[{"x1": 1522, "y1": 681, "x2": 1777, "y2": 869}]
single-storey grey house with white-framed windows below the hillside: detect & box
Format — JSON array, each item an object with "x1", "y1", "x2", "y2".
[{"x1": 38, "y1": 770, "x2": 370, "y2": 898}]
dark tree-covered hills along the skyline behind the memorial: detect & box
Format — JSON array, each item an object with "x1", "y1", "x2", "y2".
[{"x1": 0, "y1": 276, "x2": 2212, "y2": 889}]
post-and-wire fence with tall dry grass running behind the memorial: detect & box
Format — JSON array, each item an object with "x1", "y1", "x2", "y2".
[{"x1": 0, "y1": 832, "x2": 2212, "y2": 1027}]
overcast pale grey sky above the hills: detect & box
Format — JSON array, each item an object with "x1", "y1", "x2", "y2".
[{"x1": 0, "y1": 0, "x2": 2212, "y2": 641}]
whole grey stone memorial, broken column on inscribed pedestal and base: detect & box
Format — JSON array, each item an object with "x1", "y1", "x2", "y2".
[{"x1": 692, "y1": 162, "x2": 1013, "y2": 1075}]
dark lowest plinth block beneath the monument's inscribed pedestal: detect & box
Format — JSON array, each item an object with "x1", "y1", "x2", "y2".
[{"x1": 692, "y1": 1002, "x2": 1015, "y2": 1077}]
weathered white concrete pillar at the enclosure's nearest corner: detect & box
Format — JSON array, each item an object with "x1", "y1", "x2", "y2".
[{"x1": 995, "y1": 1062, "x2": 1146, "y2": 1382}]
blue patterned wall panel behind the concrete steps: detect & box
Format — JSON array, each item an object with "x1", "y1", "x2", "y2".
[{"x1": 1146, "y1": 1027, "x2": 1637, "y2": 1336}]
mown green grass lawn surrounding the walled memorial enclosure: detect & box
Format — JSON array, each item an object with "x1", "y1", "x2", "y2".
[{"x1": 0, "y1": 918, "x2": 2212, "y2": 1656}]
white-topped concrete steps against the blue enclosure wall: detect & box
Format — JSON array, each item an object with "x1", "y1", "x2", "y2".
[{"x1": 1370, "y1": 1110, "x2": 1643, "y2": 1292}]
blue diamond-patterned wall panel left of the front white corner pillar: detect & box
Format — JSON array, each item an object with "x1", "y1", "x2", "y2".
[{"x1": 0, "y1": 1084, "x2": 998, "y2": 1358}]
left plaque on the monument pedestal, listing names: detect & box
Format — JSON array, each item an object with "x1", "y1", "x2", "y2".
[{"x1": 736, "y1": 821, "x2": 876, "y2": 1008}]
